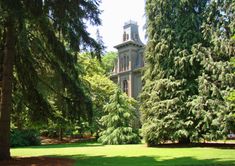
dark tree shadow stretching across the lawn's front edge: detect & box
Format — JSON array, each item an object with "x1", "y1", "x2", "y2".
[{"x1": 53, "y1": 155, "x2": 235, "y2": 166}]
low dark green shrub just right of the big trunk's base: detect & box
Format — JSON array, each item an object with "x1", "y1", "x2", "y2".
[{"x1": 10, "y1": 129, "x2": 41, "y2": 147}]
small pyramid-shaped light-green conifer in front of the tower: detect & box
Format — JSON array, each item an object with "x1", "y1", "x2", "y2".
[{"x1": 98, "y1": 89, "x2": 140, "y2": 144}]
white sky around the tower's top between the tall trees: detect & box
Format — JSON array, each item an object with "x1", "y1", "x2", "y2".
[{"x1": 88, "y1": 0, "x2": 146, "y2": 51}]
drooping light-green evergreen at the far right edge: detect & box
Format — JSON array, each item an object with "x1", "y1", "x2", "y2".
[{"x1": 188, "y1": 1, "x2": 235, "y2": 140}]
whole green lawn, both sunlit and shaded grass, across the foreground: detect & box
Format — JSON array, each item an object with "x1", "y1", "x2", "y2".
[{"x1": 11, "y1": 143, "x2": 235, "y2": 166}]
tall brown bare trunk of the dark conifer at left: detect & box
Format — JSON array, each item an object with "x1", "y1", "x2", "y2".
[{"x1": 0, "y1": 16, "x2": 16, "y2": 160}]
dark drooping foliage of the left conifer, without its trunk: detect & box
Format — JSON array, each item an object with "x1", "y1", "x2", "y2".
[{"x1": 0, "y1": 0, "x2": 102, "y2": 126}]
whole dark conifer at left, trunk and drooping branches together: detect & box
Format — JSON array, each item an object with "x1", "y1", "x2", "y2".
[{"x1": 0, "y1": 0, "x2": 101, "y2": 160}]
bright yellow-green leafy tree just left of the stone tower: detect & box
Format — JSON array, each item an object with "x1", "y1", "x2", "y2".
[{"x1": 79, "y1": 53, "x2": 118, "y2": 137}]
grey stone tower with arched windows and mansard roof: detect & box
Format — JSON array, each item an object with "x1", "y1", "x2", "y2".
[{"x1": 111, "y1": 21, "x2": 144, "y2": 98}]
